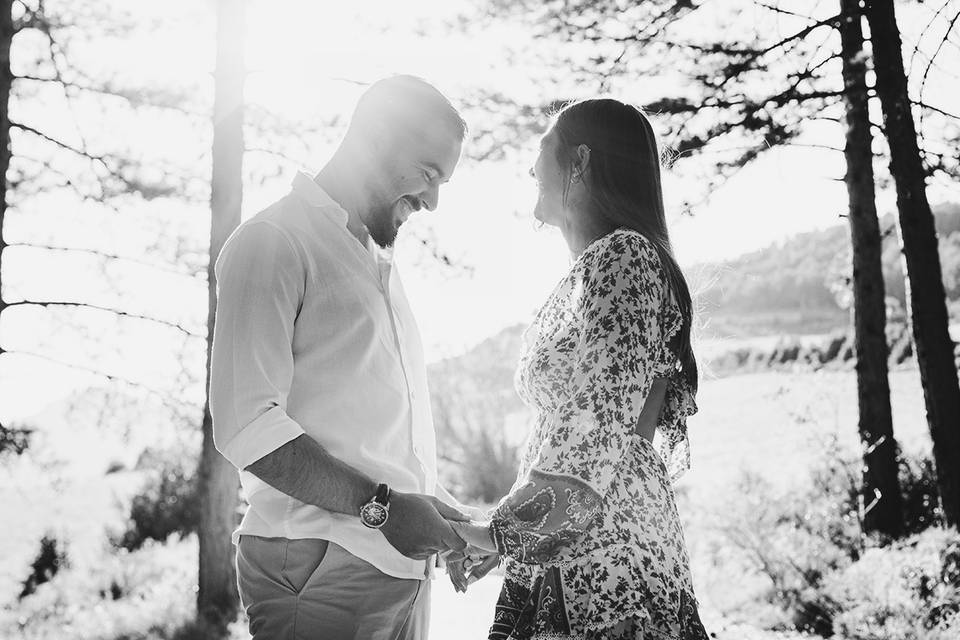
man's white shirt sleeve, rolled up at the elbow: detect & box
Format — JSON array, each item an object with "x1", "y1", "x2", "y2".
[{"x1": 210, "y1": 222, "x2": 306, "y2": 470}]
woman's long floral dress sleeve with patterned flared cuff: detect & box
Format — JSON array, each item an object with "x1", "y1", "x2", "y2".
[{"x1": 491, "y1": 233, "x2": 666, "y2": 564}]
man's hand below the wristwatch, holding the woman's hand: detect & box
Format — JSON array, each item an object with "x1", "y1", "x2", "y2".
[{"x1": 380, "y1": 491, "x2": 470, "y2": 560}]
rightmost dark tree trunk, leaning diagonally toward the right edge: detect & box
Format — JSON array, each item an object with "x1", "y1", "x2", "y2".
[{"x1": 866, "y1": 0, "x2": 960, "y2": 526}]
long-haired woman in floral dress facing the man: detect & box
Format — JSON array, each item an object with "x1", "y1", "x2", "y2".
[{"x1": 452, "y1": 99, "x2": 707, "y2": 640}]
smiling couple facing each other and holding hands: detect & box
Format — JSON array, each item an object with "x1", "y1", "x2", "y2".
[{"x1": 210, "y1": 76, "x2": 708, "y2": 640}]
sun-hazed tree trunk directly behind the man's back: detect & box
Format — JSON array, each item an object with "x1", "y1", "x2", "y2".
[{"x1": 197, "y1": 0, "x2": 245, "y2": 624}]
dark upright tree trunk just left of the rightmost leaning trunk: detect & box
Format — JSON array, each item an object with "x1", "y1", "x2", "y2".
[{"x1": 840, "y1": 0, "x2": 903, "y2": 537}]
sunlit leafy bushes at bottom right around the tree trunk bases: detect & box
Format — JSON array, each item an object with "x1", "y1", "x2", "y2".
[{"x1": 713, "y1": 442, "x2": 960, "y2": 640}]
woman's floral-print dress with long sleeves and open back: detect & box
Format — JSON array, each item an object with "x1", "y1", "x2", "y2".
[{"x1": 490, "y1": 229, "x2": 708, "y2": 640}]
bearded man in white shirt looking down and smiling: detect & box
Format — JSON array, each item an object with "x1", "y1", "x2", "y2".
[{"x1": 210, "y1": 76, "x2": 476, "y2": 640}]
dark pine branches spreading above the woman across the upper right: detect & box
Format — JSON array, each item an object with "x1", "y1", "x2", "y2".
[{"x1": 480, "y1": 0, "x2": 960, "y2": 205}]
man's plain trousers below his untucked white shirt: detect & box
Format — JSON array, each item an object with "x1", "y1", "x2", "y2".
[{"x1": 237, "y1": 535, "x2": 430, "y2": 640}]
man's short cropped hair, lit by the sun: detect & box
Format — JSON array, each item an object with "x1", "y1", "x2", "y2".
[{"x1": 350, "y1": 75, "x2": 467, "y2": 140}]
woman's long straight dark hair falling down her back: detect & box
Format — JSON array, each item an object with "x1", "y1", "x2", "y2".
[{"x1": 554, "y1": 98, "x2": 699, "y2": 393}]
